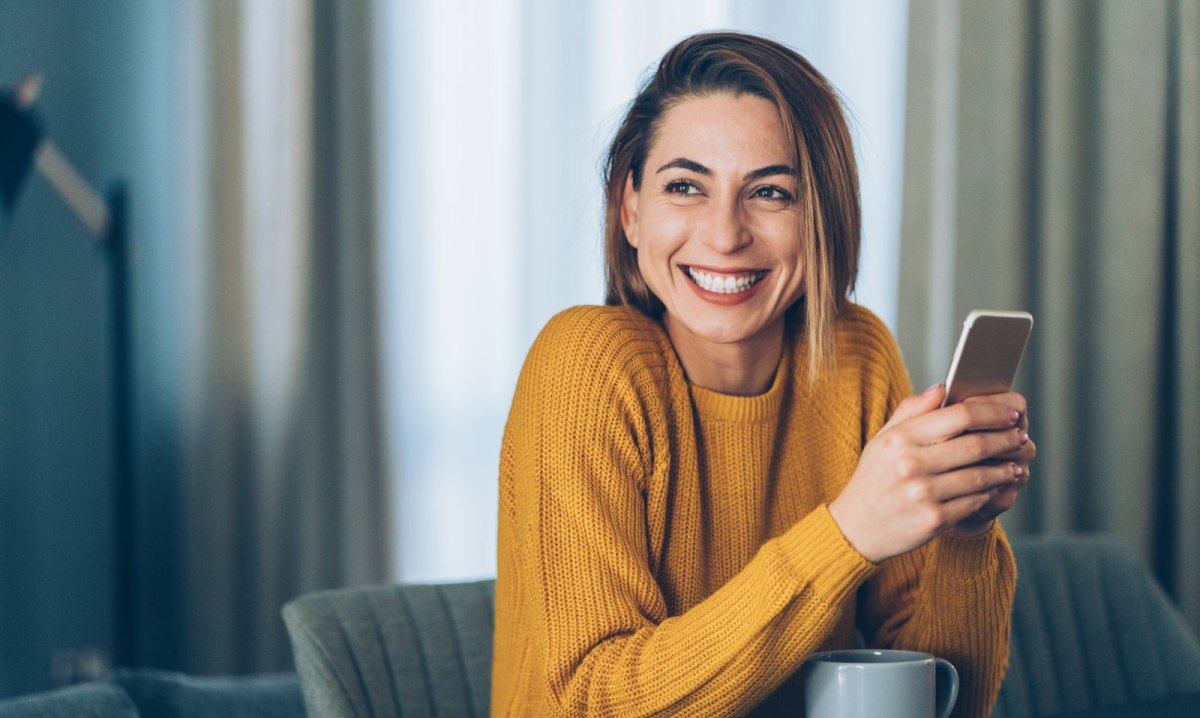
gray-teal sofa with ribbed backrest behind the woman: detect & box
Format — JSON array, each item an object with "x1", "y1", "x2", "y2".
[{"x1": 0, "y1": 535, "x2": 1200, "y2": 718}]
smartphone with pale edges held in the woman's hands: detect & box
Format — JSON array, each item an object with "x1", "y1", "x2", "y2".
[{"x1": 942, "y1": 309, "x2": 1033, "y2": 406}]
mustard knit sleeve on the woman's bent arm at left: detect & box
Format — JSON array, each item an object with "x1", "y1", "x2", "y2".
[{"x1": 502, "y1": 309, "x2": 875, "y2": 716}]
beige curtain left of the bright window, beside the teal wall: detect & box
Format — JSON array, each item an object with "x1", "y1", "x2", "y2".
[{"x1": 180, "y1": 0, "x2": 391, "y2": 672}]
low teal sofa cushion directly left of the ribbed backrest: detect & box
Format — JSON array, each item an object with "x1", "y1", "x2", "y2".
[{"x1": 113, "y1": 669, "x2": 305, "y2": 718}]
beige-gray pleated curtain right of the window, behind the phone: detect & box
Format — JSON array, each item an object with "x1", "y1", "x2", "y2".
[{"x1": 899, "y1": 0, "x2": 1200, "y2": 628}]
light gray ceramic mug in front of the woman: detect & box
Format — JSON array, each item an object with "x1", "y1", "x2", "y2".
[{"x1": 804, "y1": 648, "x2": 959, "y2": 718}]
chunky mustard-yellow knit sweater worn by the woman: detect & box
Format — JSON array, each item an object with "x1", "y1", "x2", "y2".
[{"x1": 492, "y1": 305, "x2": 1015, "y2": 717}]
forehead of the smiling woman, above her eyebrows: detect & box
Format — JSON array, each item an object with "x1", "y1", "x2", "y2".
[{"x1": 647, "y1": 94, "x2": 794, "y2": 172}]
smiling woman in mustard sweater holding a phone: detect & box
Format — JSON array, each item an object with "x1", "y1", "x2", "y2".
[{"x1": 492, "y1": 32, "x2": 1034, "y2": 716}]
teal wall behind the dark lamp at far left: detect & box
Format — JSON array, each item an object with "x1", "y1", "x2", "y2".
[{"x1": 0, "y1": 0, "x2": 182, "y2": 696}]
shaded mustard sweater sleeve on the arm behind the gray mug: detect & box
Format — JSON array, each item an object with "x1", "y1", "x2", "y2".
[{"x1": 859, "y1": 314, "x2": 1016, "y2": 718}]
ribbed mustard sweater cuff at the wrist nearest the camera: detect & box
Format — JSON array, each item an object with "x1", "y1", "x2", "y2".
[{"x1": 775, "y1": 504, "x2": 878, "y2": 605}]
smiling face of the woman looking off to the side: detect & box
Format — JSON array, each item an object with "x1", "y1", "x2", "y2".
[{"x1": 622, "y1": 94, "x2": 804, "y2": 360}]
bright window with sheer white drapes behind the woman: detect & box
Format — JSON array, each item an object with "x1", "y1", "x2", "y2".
[{"x1": 378, "y1": 0, "x2": 907, "y2": 581}]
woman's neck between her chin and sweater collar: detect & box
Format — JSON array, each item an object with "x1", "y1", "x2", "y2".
[{"x1": 666, "y1": 315, "x2": 784, "y2": 396}]
